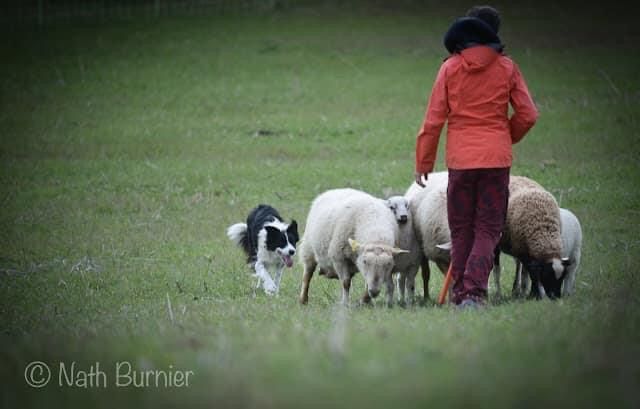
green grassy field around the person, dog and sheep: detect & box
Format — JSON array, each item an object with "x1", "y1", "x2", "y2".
[{"x1": 0, "y1": 2, "x2": 640, "y2": 408}]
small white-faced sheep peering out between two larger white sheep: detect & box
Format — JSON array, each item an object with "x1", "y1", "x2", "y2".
[{"x1": 385, "y1": 196, "x2": 424, "y2": 303}]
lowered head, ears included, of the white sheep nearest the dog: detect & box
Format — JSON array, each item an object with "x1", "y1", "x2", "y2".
[{"x1": 349, "y1": 239, "x2": 408, "y2": 298}]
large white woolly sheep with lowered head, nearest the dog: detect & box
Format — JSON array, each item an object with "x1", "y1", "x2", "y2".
[{"x1": 298, "y1": 189, "x2": 406, "y2": 305}]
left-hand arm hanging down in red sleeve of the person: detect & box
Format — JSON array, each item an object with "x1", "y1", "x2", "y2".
[{"x1": 416, "y1": 64, "x2": 449, "y2": 186}]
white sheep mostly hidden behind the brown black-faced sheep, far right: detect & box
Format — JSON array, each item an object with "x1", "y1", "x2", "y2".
[{"x1": 513, "y1": 208, "x2": 582, "y2": 296}]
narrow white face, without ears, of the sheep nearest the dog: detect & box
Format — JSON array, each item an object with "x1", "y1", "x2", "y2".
[{"x1": 356, "y1": 245, "x2": 394, "y2": 298}]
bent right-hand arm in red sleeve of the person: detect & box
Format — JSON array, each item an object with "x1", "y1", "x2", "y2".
[{"x1": 509, "y1": 63, "x2": 538, "y2": 144}]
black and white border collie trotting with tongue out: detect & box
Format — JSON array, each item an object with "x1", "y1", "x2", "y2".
[{"x1": 227, "y1": 204, "x2": 299, "y2": 295}]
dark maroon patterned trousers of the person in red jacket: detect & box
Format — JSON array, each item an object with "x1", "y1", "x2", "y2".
[{"x1": 447, "y1": 168, "x2": 509, "y2": 304}]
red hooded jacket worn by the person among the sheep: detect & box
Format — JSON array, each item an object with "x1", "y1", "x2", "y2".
[{"x1": 416, "y1": 46, "x2": 538, "y2": 173}]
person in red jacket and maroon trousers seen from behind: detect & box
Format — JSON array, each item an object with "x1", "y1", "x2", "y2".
[{"x1": 415, "y1": 6, "x2": 538, "y2": 306}]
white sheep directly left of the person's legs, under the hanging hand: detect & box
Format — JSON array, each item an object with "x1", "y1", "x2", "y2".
[{"x1": 409, "y1": 183, "x2": 451, "y2": 300}]
